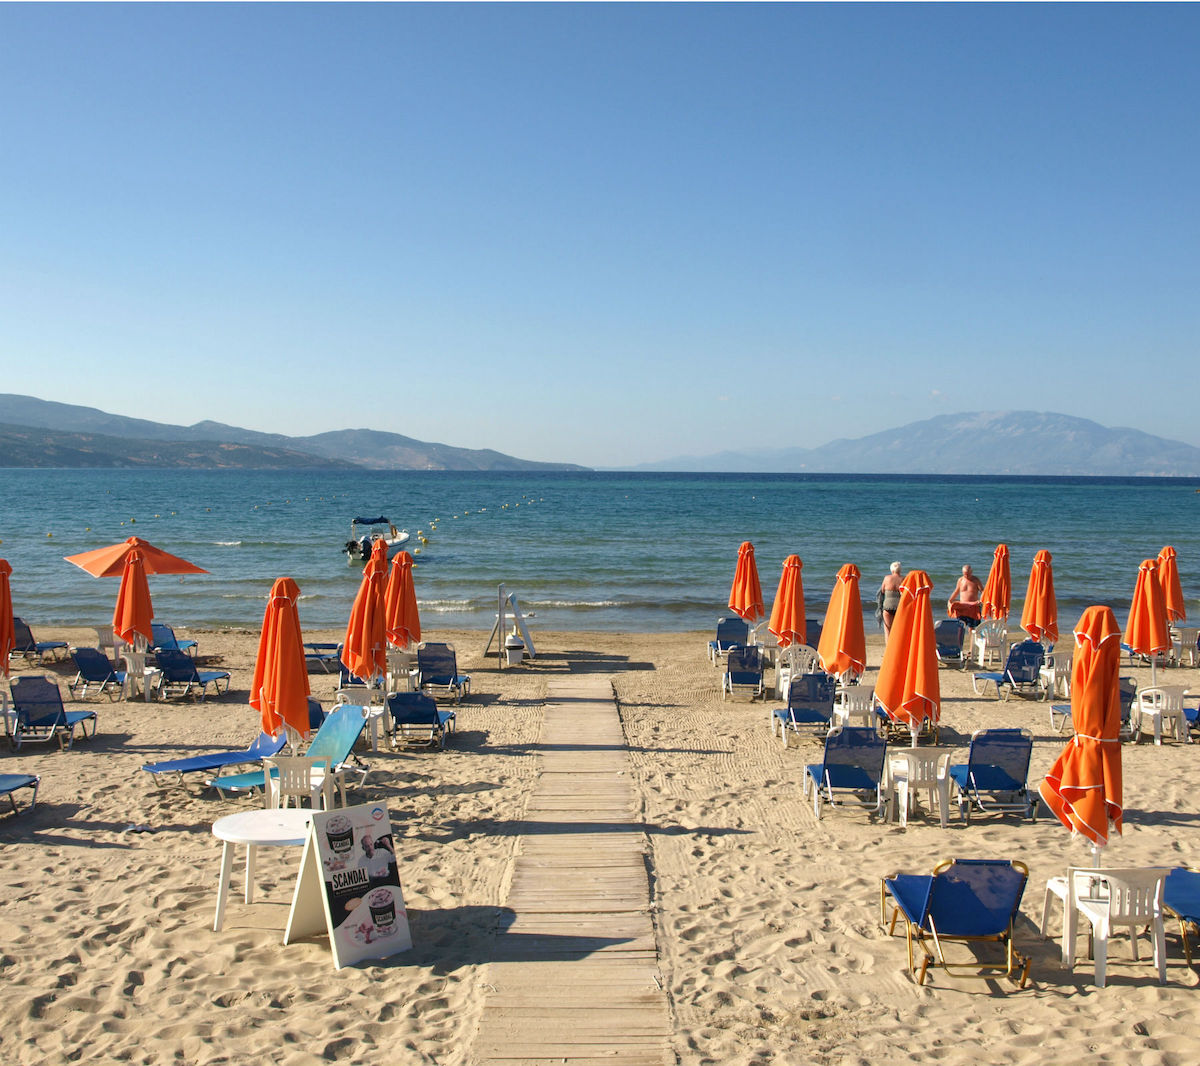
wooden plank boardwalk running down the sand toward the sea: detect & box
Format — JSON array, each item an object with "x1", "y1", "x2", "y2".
[{"x1": 470, "y1": 677, "x2": 673, "y2": 1066}]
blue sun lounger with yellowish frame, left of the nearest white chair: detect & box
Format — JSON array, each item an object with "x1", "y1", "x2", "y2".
[{"x1": 880, "y1": 858, "x2": 1030, "y2": 988}]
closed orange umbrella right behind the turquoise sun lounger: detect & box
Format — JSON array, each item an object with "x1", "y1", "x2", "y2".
[{"x1": 250, "y1": 577, "x2": 310, "y2": 737}]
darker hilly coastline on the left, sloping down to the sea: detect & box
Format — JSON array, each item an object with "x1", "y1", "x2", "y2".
[{"x1": 0, "y1": 394, "x2": 587, "y2": 471}]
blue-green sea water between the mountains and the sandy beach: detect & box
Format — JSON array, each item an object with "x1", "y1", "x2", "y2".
[{"x1": 0, "y1": 471, "x2": 1200, "y2": 633}]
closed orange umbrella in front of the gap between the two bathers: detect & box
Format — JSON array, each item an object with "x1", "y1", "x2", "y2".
[{"x1": 875, "y1": 570, "x2": 942, "y2": 738}]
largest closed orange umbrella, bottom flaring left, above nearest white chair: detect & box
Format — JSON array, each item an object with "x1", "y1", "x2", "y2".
[{"x1": 1039, "y1": 607, "x2": 1122, "y2": 848}]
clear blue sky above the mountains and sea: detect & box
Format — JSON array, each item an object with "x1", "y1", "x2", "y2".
[{"x1": 0, "y1": 4, "x2": 1200, "y2": 466}]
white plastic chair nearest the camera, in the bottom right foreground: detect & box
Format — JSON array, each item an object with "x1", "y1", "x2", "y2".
[{"x1": 1063, "y1": 867, "x2": 1170, "y2": 988}]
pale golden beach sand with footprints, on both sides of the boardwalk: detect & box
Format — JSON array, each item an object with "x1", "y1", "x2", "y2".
[{"x1": 0, "y1": 627, "x2": 1200, "y2": 1066}]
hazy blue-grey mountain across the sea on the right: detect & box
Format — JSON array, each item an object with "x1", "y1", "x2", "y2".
[{"x1": 631, "y1": 411, "x2": 1200, "y2": 477}]
